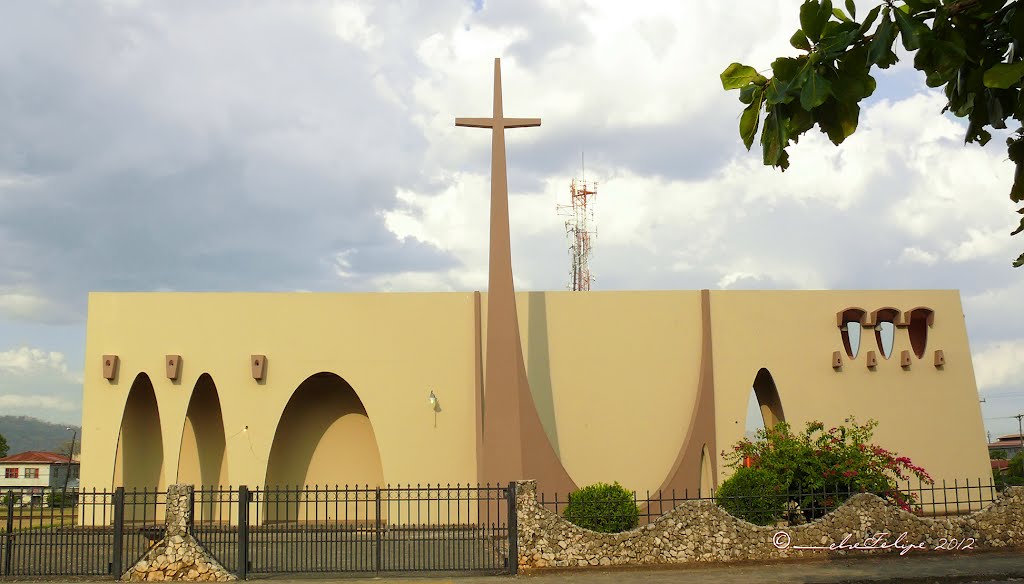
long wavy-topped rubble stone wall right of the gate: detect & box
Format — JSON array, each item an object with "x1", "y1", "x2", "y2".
[{"x1": 516, "y1": 481, "x2": 1024, "y2": 570}]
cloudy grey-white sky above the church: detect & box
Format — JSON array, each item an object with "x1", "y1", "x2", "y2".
[{"x1": 0, "y1": 0, "x2": 1024, "y2": 436}]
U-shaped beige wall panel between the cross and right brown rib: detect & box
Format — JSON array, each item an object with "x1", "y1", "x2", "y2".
[{"x1": 481, "y1": 291, "x2": 701, "y2": 493}]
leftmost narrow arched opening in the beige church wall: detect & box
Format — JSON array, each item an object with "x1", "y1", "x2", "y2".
[{"x1": 113, "y1": 373, "x2": 164, "y2": 520}]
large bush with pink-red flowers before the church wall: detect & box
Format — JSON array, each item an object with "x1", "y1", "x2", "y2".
[{"x1": 722, "y1": 417, "x2": 933, "y2": 519}]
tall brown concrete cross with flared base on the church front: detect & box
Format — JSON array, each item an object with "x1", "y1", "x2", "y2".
[{"x1": 455, "y1": 58, "x2": 573, "y2": 493}]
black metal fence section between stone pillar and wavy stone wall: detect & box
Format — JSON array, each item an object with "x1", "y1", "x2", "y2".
[{"x1": 191, "y1": 485, "x2": 516, "y2": 578}]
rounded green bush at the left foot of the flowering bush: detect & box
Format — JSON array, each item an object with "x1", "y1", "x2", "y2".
[{"x1": 715, "y1": 467, "x2": 788, "y2": 526}]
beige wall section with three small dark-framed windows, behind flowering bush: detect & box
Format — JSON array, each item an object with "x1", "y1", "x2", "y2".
[{"x1": 711, "y1": 291, "x2": 990, "y2": 484}]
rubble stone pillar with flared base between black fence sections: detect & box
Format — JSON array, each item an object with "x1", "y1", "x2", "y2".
[{"x1": 121, "y1": 485, "x2": 237, "y2": 582}]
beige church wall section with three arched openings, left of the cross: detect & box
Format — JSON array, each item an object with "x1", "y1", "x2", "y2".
[{"x1": 82, "y1": 293, "x2": 476, "y2": 488}]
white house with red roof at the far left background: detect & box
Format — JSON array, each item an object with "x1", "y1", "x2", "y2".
[{"x1": 0, "y1": 451, "x2": 80, "y2": 505}]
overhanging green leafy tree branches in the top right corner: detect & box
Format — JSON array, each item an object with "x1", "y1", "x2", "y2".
[{"x1": 721, "y1": 0, "x2": 1024, "y2": 267}]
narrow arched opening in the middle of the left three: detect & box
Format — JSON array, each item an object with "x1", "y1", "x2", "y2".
[{"x1": 177, "y1": 373, "x2": 228, "y2": 518}]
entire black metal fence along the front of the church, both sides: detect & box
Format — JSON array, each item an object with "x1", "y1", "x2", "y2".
[{"x1": 0, "y1": 479, "x2": 1000, "y2": 579}]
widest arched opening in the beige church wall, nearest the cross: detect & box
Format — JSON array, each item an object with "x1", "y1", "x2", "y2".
[{"x1": 265, "y1": 373, "x2": 384, "y2": 520}]
